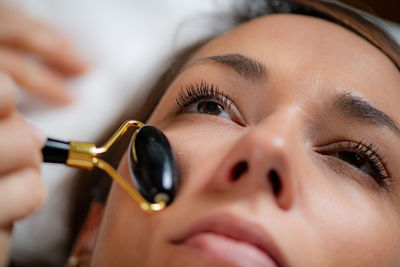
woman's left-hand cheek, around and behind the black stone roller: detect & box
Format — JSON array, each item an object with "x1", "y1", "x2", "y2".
[{"x1": 93, "y1": 125, "x2": 233, "y2": 266}]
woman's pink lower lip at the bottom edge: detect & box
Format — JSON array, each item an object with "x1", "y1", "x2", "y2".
[{"x1": 184, "y1": 233, "x2": 277, "y2": 267}]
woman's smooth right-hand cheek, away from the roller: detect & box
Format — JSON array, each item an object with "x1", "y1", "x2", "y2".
[{"x1": 301, "y1": 173, "x2": 400, "y2": 266}]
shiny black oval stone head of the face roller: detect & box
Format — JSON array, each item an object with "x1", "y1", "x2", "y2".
[{"x1": 129, "y1": 125, "x2": 179, "y2": 205}]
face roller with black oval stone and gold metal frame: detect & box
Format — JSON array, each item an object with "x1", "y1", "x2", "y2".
[{"x1": 42, "y1": 121, "x2": 179, "y2": 211}]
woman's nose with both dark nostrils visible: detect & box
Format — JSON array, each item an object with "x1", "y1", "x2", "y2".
[{"x1": 212, "y1": 112, "x2": 302, "y2": 210}]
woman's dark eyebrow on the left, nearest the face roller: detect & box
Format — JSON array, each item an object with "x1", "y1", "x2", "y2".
[{"x1": 195, "y1": 54, "x2": 267, "y2": 82}]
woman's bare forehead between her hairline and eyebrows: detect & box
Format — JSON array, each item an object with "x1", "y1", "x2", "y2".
[{"x1": 189, "y1": 14, "x2": 400, "y2": 121}]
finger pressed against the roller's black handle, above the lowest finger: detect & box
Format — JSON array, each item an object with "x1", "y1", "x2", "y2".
[{"x1": 0, "y1": 113, "x2": 43, "y2": 175}]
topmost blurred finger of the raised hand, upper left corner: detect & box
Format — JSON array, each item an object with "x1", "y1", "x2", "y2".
[{"x1": 0, "y1": 5, "x2": 87, "y2": 74}]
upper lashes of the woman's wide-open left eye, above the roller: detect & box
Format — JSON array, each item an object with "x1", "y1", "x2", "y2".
[{"x1": 176, "y1": 81, "x2": 232, "y2": 112}]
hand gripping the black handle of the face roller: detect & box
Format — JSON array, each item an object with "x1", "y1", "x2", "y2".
[{"x1": 0, "y1": 73, "x2": 46, "y2": 266}]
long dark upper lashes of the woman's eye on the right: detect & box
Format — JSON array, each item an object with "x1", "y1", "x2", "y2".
[{"x1": 337, "y1": 140, "x2": 390, "y2": 189}]
